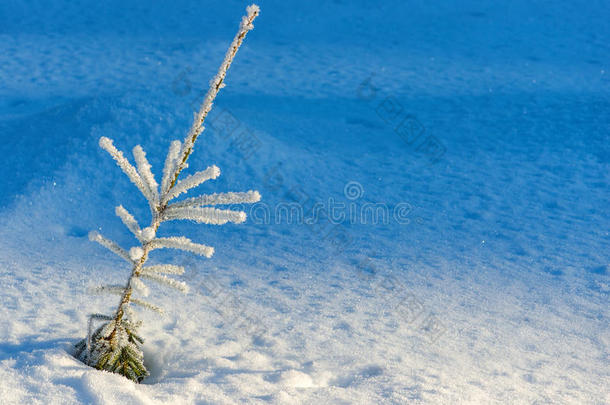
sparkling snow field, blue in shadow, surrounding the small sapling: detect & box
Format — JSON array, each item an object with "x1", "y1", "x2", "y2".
[{"x1": 0, "y1": 0, "x2": 610, "y2": 404}]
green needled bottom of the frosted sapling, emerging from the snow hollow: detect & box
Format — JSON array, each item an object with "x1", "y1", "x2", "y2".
[{"x1": 74, "y1": 320, "x2": 149, "y2": 383}]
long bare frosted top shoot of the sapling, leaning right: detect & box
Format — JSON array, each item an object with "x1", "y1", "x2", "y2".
[{"x1": 171, "y1": 4, "x2": 260, "y2": 186}]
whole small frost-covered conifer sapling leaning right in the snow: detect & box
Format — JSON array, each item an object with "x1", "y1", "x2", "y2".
[{"x1": 75, "y1": 5, "x2": 260, "y2": 382}]
